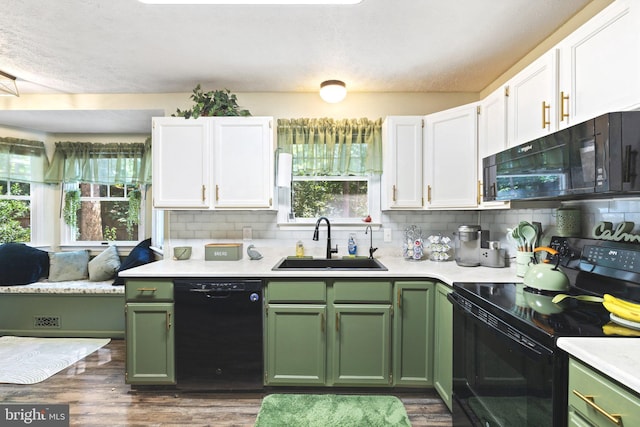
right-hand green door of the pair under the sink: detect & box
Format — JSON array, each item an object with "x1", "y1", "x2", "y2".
[{"x1": 329, "y1": 304, "x2": 391, "y2": 386}]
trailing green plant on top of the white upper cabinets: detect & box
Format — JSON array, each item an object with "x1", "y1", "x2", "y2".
[{"x1": 172, "y1": 84, "x2": 251, "y2": 119}]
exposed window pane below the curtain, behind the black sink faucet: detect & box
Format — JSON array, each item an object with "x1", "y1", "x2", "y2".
[{"x1": 293, "y1": 181, "x2": 369, "y2": 218}]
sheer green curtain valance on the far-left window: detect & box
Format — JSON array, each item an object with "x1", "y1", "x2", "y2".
[{"x1": 0, "y1": 138, "x2": 49, "y2": 182}]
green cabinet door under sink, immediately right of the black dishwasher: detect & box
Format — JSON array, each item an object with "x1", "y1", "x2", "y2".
[{"x1": 265, "y1": 304, "x2": 327, "y2": 385}]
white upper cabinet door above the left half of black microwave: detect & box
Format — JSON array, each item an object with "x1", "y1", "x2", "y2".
[{"x1": 507, "y1": 49, "x2": 558, "y2": 146}]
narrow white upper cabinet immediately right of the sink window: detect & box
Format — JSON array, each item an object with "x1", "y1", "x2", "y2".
[{"x1": 381, "y1": 116, "x2": 423, "y2": 209}]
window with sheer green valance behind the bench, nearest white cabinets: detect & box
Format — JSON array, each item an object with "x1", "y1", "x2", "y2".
[{"x1": 46, "y1": 138, "x2": 151, "y2": 245}]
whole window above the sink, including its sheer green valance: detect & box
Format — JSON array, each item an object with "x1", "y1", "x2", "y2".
[{"x1": 278, "y1": 119, "x2": 382, "y2": 224}]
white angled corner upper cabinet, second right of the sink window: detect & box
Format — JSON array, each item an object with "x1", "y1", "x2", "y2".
[{"x1": 423, "y1": 103, "x2": 479, "y2": 209}]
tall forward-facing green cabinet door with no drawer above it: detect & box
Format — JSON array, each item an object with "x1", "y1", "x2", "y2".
[{"x1": 393, "y1": 281, "x2": 435, "y2": 386}]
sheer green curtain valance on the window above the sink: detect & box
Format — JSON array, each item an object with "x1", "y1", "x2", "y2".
[{"x1": 278, "y1": 118, "x2": 382, "y2": 176}]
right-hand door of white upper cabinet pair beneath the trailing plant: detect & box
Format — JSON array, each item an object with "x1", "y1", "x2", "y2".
[{"x1": 213, "y1": 117, "x2": 274, "y2": 208}]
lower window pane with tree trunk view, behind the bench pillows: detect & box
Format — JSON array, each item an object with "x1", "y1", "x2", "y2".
[{"x1": 77, "y1": 200, "x2": 138, "y2": 241}]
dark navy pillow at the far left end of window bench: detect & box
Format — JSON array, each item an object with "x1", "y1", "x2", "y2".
[{"x1": 0, "y1": 243, "x2": 49, "y2": 286}]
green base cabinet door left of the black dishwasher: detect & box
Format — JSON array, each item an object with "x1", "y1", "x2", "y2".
[{"x1": 125, "y1": 302, "x2": 176, "y2": 385}]
